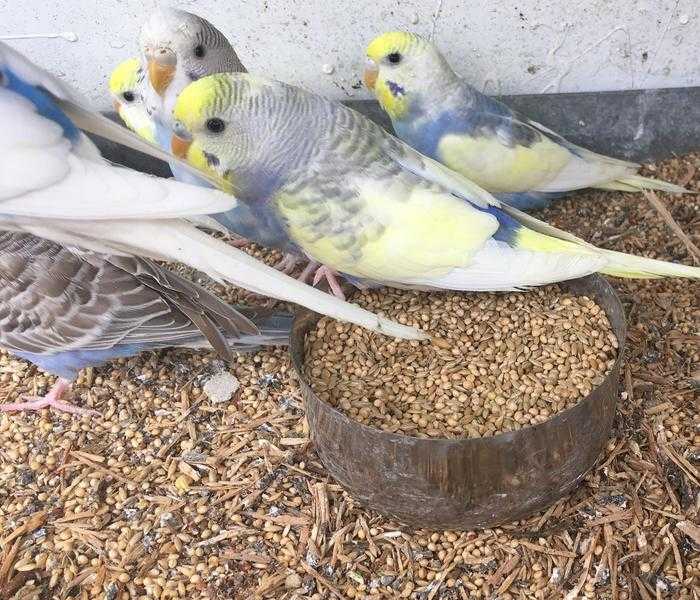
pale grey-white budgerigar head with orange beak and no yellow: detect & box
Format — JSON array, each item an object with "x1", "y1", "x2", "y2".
[{"x1": 140, "y1": 8, "x2": 244, "y2": 97}]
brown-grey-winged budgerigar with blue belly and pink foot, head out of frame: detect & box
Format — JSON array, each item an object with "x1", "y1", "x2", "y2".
[{"x1": 0, "y1": 231, "x2": 292, "y2": 414}]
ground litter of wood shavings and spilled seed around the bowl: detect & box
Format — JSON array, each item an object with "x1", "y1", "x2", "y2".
[{"x1": 0, "y1": 155, "x2": 700, "y2": 600}]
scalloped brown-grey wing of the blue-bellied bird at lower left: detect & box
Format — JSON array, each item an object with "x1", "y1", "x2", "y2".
[{"x1": 0, "y1": 232, "x2": 268, "y2": 359}]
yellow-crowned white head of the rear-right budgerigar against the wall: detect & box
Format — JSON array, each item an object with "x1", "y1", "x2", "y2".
[{"x1": 364, "y1": 31, "x2": 454, "y2": 119}]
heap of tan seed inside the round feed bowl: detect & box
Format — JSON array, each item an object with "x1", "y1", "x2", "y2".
[{"x1": 306, "y1": 285, "x2": 618, "y2": 438}]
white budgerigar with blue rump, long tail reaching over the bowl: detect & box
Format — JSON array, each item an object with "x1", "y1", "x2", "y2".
[{"x1": 0, "y1": 44, "x2": 425, "y2": 356}]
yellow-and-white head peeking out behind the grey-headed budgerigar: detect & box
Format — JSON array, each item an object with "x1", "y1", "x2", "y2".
[{"x1": 109, "y1": 58, "x2": 156, "y2": 144}]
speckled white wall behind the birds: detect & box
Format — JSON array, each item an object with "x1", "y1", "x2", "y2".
[{"x1": 0, "y1": 0, "x2": 700, "y2": 108}]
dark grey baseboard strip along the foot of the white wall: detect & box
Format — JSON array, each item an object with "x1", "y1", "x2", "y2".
[{"x1": 95, "y1": 87, "x2": 700, "y2": 175}]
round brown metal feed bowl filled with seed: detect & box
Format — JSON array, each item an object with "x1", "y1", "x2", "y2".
[{"x1": 290, "y1": 275, "x2": 626, "y2": 530}]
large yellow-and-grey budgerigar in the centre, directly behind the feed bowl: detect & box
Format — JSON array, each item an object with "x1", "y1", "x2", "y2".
[{"x1": 173, "y1": 73, "x2": 700, "y2": 291}]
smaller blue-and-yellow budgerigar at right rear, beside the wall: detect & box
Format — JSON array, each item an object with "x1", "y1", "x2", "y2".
[{"x1": 364, "y1": 31, "x2": 687, "y2": 210}]
